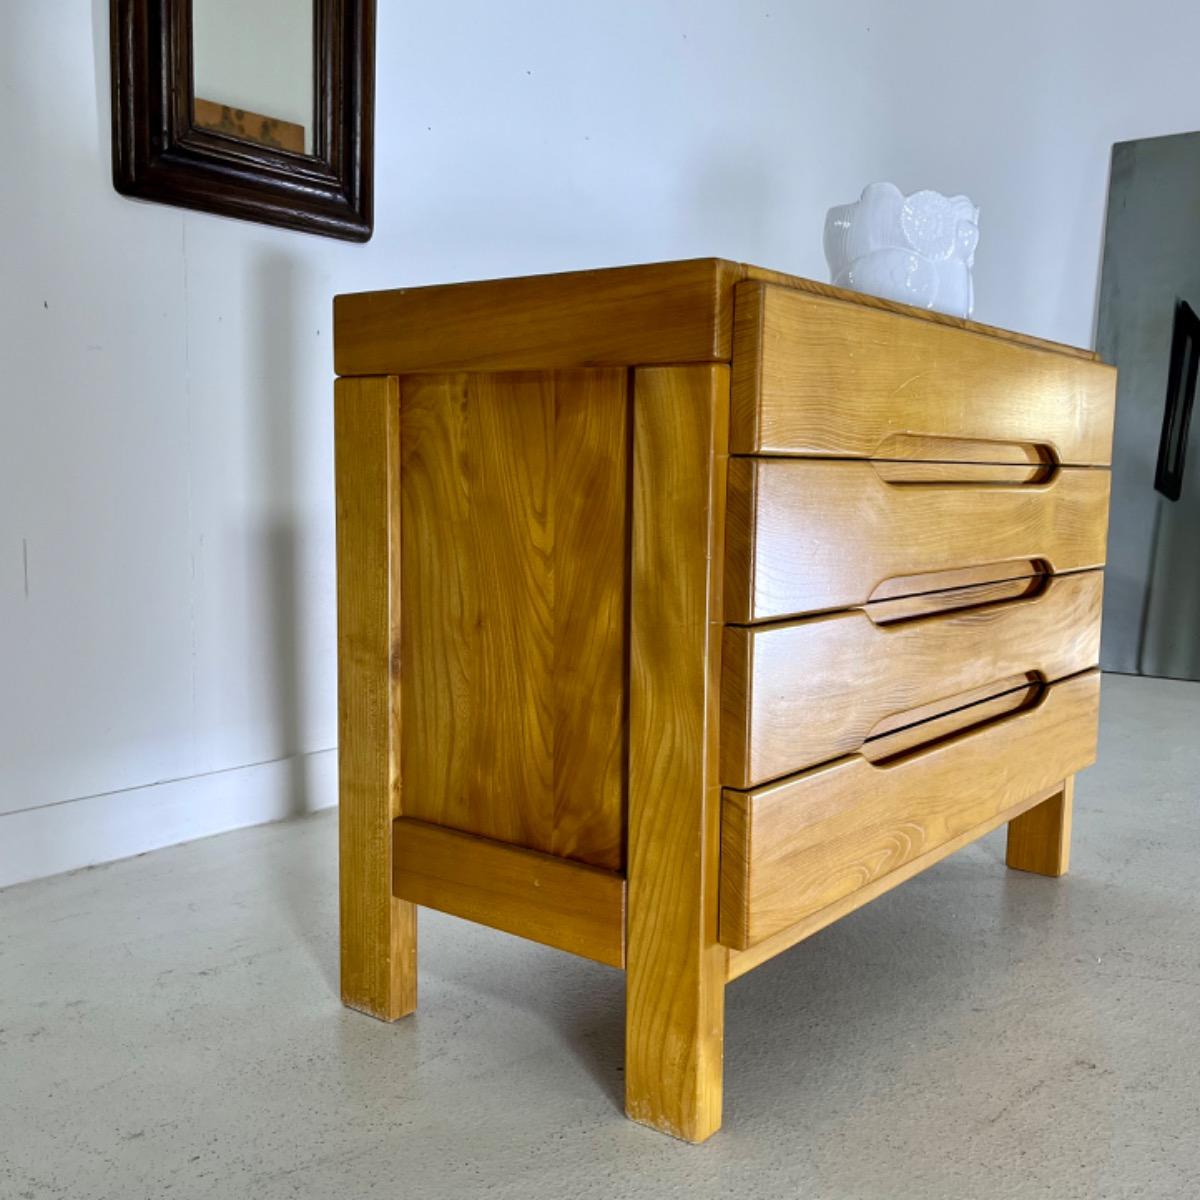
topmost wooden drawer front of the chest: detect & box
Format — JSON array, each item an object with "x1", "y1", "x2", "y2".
[{"x1": 730, "y1": 283, "x2": 1116, "y2": 466}]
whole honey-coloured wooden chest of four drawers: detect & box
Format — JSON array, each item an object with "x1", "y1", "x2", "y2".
[{"x1": 335, "y1": 259, "x2": 1115, "y2": 1141}]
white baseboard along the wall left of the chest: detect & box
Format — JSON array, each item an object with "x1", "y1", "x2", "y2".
[{"x1": 0, "y1": 750, "x2": 337, "y2": 888}]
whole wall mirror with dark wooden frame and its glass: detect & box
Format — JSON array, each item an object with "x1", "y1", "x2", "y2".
[{"x1": 110, "y1": 0, "x2": 374, "y2": 241}]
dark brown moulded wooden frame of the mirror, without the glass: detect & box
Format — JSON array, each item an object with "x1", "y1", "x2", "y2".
[{"x1": 110, "y1": 0, "x2": 374, "y2": 241}]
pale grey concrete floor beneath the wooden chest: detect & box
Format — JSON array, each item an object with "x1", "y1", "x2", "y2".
[{"x1": 0, "y1": 677, "x2": 1200, "y2": 1200}]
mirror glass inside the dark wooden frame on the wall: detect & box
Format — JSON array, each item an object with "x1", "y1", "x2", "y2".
[{"x1": 192, "y1": 0, "x2": 316, "y2": 154}]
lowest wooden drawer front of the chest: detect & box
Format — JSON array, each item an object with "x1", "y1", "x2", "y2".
[{"x1": 720, "y1": 671, "x2": 1100, "y2": 949}]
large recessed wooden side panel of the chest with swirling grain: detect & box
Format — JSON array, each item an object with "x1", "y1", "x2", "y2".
[{"x1": 400, "y1": 370, "x2": 629, "y2": 870}]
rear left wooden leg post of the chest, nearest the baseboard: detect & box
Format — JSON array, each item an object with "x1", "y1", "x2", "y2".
[{"x1": 334, "y1": 377, "x2": 416, "y2": 1021}]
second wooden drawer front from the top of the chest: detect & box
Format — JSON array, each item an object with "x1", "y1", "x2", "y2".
[{"x1": 725, "y1": 458, "x2": 1109, "y2": 624}]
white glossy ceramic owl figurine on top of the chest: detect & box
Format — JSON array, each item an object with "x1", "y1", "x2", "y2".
[{"x1": 824, "y1": 184, "x2": 979, "y2": 317}]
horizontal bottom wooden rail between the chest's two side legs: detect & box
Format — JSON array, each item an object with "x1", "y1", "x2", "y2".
[{"x1": 392, "y1": 817, "x2": 625, "y2": 967}]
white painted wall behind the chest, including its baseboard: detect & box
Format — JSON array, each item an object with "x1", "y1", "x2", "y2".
[{"x1": 0, "y1": 0, "x2": 1200, "y2": 882}]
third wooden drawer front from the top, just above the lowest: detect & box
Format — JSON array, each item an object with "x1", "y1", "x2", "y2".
[{"x1": 721, "y1": 571, "x2": 1103, "y2": 787}]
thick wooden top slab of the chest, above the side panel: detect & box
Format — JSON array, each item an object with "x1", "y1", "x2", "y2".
[{"x1": 334, "y1": 258, "x2": 1094, "y2": 376}]
